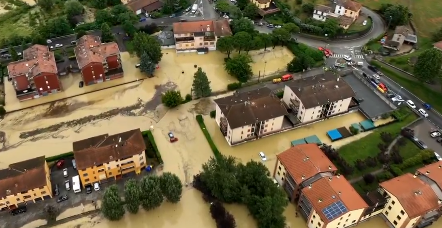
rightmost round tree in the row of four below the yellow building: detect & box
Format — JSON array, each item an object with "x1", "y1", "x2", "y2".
[{"x1": 160, "y1": 172, "x2": 183, "y2": 203}]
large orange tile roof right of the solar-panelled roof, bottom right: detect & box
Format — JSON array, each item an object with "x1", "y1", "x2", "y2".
[{"x1": 380, "y1": 173, "x2": 439, "y2": 218}]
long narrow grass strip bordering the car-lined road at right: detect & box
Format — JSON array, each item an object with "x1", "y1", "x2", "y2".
[{"x1": 371, "y1": 61, "x2": 442, "y2": 112}]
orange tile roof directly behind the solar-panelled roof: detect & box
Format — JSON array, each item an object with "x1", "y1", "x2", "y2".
[{"x1": 276, "y1": 144, "x2": 338, "y2": 184}]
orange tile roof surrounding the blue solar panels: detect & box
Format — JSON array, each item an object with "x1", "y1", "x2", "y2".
[{"x1": 302, "y1": 176, "x2": 368, "y2": 223}]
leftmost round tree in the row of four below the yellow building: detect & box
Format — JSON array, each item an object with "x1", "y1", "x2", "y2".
[{"x1": 101, "y1": 185, "x2": 126, "y2": 221}]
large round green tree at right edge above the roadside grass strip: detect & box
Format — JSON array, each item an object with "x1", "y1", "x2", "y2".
[{"x1": 414, "y1": 48, "x2": 442, "y2": 82}]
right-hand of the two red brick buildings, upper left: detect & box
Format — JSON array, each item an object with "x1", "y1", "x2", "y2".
[{"x1": 74, "y1": 35, "x2": 123, "y2": 85}]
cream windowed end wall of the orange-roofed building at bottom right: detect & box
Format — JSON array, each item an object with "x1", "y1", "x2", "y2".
[{"x1": 382, "y1": 190, "x2": 420, "y2": 227}]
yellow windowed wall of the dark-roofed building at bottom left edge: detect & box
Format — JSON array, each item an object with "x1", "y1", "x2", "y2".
[{"x1": 0, "y1": 162, "x2": 52, "y2": 209}]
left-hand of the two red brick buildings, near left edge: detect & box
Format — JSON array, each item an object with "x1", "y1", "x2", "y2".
[{"x1": 8, "y1": 44, "x2": 62, "y2": 101}]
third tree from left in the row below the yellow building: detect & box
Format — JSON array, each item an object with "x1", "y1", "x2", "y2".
[{"x1": 140, "y1": 176, "x2": 164, "y2": 211}]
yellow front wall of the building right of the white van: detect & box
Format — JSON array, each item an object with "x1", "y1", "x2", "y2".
[{"x1": 78, "y1": 151, "x2": 146, "y2": 188}]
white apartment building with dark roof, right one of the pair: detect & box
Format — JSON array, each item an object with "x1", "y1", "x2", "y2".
[{"x1": 282, "y1": 71, "x2": 355, "y2": 123}]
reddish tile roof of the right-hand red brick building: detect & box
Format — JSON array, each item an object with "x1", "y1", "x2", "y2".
[{"x1": 74, "y1": 35, "x2": 120, "y2": 69}]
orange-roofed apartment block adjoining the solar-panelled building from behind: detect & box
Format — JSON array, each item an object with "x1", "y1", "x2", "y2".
[{"x1": 273, "y1": 144, "x2": 338, "y2": 203}]
